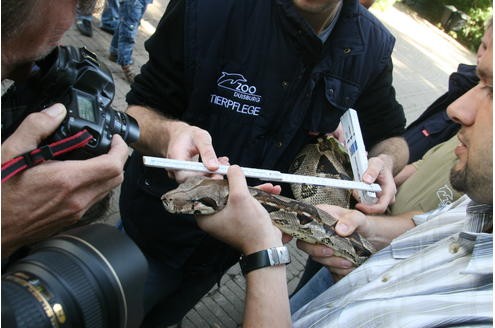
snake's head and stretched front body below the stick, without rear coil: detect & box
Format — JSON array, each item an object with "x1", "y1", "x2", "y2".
[{"x1": 162, "y1": 176, "x2": 375, "y2": 265}]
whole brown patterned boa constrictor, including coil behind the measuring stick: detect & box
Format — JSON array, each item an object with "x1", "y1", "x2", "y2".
[{"x1": 162, "y1": 137, "x2": 375, "y2": 265}]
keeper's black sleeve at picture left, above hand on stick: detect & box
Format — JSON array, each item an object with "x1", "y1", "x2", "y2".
[{"x1": 126, "y1": 0, "x2": 187, "y2": 118}]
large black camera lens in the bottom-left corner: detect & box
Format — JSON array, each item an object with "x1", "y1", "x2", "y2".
[{"x1": 2, "y1": 224, "x2": 147, "y2": 328}]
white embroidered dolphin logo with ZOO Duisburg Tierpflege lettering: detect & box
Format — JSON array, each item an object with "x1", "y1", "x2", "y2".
[{"x1": 210, "y1": 72, "x2": 261, "y2": 116}]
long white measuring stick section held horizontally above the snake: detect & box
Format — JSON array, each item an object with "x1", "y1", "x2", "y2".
[{"x1": 143, "y1": 156, "x2": 381, "y2": 192}]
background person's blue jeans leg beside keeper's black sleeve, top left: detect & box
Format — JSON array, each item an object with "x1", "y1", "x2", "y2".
[{"x1": 110, "y1": 0, "x2": 153, "y2": 66}]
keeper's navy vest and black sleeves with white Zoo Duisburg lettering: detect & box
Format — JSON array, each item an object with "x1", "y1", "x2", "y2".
[{"x1": 121, "y1": 0, "x2": 405, "y2": 265}]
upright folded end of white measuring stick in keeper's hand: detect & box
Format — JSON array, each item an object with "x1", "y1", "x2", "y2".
[{"x1": 340, "y1": 108, "x2": 378, "y2": 204}]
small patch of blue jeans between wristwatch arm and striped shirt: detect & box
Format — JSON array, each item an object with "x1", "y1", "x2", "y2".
[{"x1": 290, "y1": 267, "x2": 334, "y2": 314}]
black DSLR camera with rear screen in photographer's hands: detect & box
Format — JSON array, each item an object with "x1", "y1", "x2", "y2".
[{"x1": 33, "y1": 46, "x2": 139, "y2": 159}]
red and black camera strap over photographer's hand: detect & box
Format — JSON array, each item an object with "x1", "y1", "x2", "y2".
[{"x1": 2, "y1": 130, "x2": 93, "y2": 183}]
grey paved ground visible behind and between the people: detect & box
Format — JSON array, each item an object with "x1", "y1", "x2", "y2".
[{"x1": 63, "y1": 0, "x2": 476, "y2": 328}]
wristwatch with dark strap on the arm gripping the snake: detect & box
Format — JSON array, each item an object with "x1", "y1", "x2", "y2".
[{"x1": 239, "y1": 246, "x2": 290, "y2": 275}]
